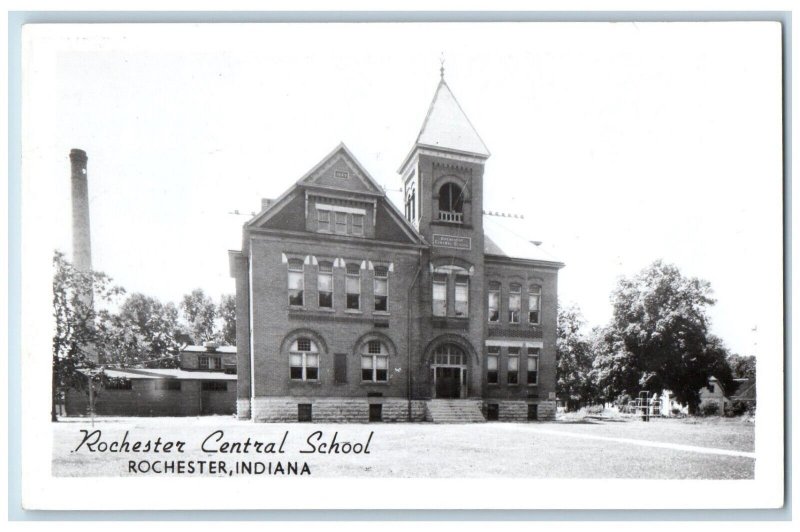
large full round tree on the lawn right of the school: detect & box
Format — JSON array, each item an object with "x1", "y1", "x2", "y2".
[{"x1": 607, "y1": 261, "x2": 728, "y2": 412}]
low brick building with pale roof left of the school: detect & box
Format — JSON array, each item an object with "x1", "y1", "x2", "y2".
[{"x1": 64, "y1": 344, "x2": 236, "y2": 416}]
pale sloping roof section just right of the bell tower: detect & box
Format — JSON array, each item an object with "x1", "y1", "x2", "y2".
[{"x1": 483, "y1": 214, "x2": 564, "y2": 267}]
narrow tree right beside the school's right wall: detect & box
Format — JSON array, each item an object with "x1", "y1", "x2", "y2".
[{"x1": 556, "y1": 306, "x2": 597, "y2": 410}]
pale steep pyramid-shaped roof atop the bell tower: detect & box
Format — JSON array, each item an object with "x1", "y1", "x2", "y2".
[{"x1": 403, "y1": 78, "x2": 491, "y2": 170}]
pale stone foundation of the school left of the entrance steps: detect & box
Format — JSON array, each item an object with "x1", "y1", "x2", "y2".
[{"x1": 250, "y1": 397, "x2": 425, "y2": 423}]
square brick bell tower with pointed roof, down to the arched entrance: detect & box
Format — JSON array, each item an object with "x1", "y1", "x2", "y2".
[{"x1": 399, "y1": 69, "x2": 489, "y2": 399}]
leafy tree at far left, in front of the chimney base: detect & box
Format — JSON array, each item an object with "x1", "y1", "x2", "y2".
[{"x1": 51, "y1": 251, "x2": 125, "y2": 421}]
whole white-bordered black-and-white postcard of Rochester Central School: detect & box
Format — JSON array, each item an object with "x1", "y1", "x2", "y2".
[{"x1": 15, "y1": 21, "x2": 784, "y2": 510}]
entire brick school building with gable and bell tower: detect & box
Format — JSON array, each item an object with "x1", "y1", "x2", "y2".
[{"x1": 230, "y1": 79, "x2": 563, "y2": 421}]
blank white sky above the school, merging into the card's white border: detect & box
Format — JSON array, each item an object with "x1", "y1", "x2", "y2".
[{"x1": 22, "y1": 23, "x2": 782, "y2": 361}]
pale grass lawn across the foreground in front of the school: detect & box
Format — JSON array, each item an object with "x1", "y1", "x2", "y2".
[{"x1": 52, "y1": 417, "x2": 755, "y2": 479}]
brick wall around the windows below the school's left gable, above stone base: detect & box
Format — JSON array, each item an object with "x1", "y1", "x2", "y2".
[{"x1": 250, "y1": 235, "x2": 418, "y2": 400}]
